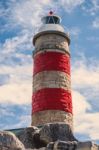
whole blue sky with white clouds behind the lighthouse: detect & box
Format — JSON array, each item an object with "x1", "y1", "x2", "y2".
[{"x1": 0, "y1": 0, "x2": 99, "y2": 143}]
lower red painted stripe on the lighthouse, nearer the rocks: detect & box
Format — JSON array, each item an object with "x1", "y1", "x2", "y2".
[{"x1": 32, "y1": 88, "x2": 72, "y2": 113}]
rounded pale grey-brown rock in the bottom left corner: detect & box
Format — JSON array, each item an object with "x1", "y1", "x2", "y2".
[{"x1": 0, "y1": 131, "x2": 25, "y2": 150}]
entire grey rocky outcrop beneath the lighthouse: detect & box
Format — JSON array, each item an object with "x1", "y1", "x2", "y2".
[{"x1": 0, "y1": 123, "x2": 99, "y2": 150}]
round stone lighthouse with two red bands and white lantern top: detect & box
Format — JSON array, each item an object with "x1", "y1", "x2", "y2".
[{"x1": 32, "y1": 11, "x2": 72, "y2": 128}]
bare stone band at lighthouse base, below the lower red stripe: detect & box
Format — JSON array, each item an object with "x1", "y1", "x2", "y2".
[{"x1": 31, "y1": 110, "x2": 73, "y2": 130}]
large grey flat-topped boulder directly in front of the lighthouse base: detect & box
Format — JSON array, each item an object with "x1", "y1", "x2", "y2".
[{"x1": 40, "y1": 123, "x2": 77, "y2": 144}]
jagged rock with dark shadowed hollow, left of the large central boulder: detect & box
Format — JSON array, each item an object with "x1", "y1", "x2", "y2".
[{"x1": 17, "y1": 126, "x2": 46, "y2": 149}]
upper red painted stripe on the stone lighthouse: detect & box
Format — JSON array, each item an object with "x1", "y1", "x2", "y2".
[{"x1": 34, "y1": 52, "x2": 70, "y2": 75}]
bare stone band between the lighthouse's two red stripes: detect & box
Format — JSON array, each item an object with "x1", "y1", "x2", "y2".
[{"x1": 33, "y1": 71, "x2": 71, "y2": 92}]
